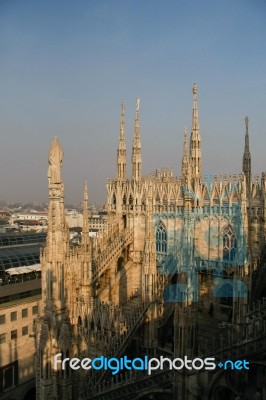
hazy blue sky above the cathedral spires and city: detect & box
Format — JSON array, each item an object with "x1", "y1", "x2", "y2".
[{"x1": 0, "y1": 0, "x2": 266, "y2": 204}]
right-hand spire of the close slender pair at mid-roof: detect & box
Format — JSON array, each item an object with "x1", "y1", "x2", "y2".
[{"x1": 131, "y1": 97, "x2": 142, "y2": 181}]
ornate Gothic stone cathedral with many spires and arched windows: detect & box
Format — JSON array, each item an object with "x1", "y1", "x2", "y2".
[{"x1": 34, "y1": 84, "x2": 266, "y2": 400}]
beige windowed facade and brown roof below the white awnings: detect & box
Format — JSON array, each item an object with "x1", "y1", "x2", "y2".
[{"x1": 0, "y1": 267, "x2": 41, "y2": 400}]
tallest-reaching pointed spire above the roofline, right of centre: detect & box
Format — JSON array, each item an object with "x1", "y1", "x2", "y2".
[{"x1": 189, "y1": 83, "x2": 202, "y2": 179}]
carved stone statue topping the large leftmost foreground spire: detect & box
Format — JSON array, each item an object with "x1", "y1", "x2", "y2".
[{"x1": 48, "y1": 137, "x2": 64, "y2": 184}]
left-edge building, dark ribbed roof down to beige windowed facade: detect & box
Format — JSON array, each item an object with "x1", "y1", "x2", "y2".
[{"x1": 0, "y1": 233, "x2": 46, "y2": 400}]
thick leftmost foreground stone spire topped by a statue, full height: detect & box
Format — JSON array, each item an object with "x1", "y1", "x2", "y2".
[{"x1": 34, "y1": 138, "x2": 72, "y2": 400}]
